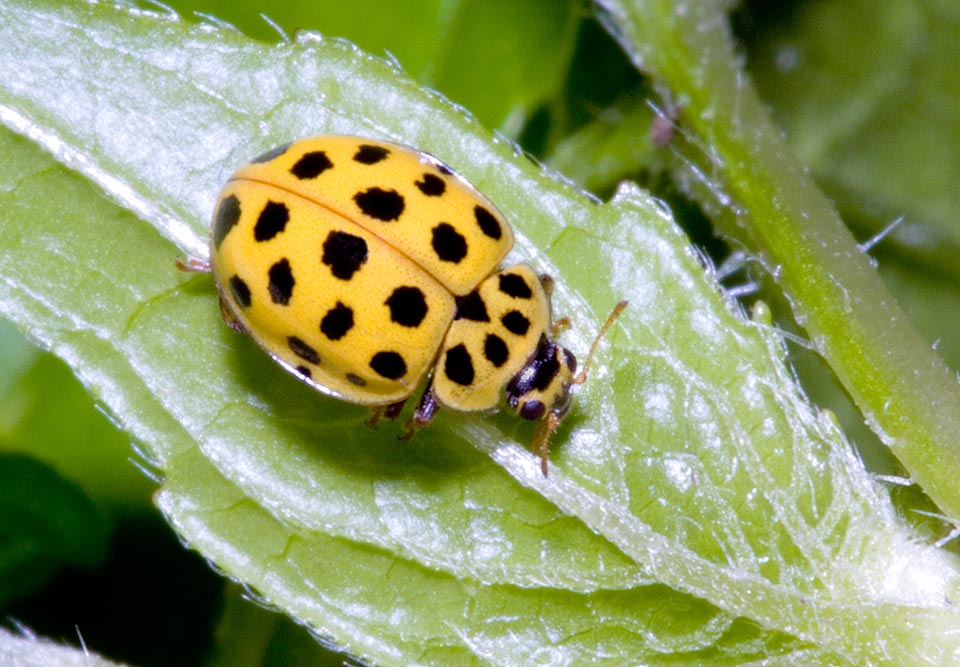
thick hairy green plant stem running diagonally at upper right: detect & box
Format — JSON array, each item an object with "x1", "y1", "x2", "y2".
[{"x1": 598, "y1": 0, "x2": 960, "y2": 517}]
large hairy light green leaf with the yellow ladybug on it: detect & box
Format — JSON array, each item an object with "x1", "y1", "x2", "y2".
[{"x1": 0, "y1": 1, "x2": 958, "y2": 665}]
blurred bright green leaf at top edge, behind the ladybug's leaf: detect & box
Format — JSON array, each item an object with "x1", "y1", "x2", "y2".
[{"x1": 152, "y1": 0, "x2": 581, "y2": 131}]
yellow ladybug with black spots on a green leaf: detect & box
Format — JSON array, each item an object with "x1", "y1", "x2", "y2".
[{"x1": 203, "y1": 136, "x2": 626, "y2": 475}]
